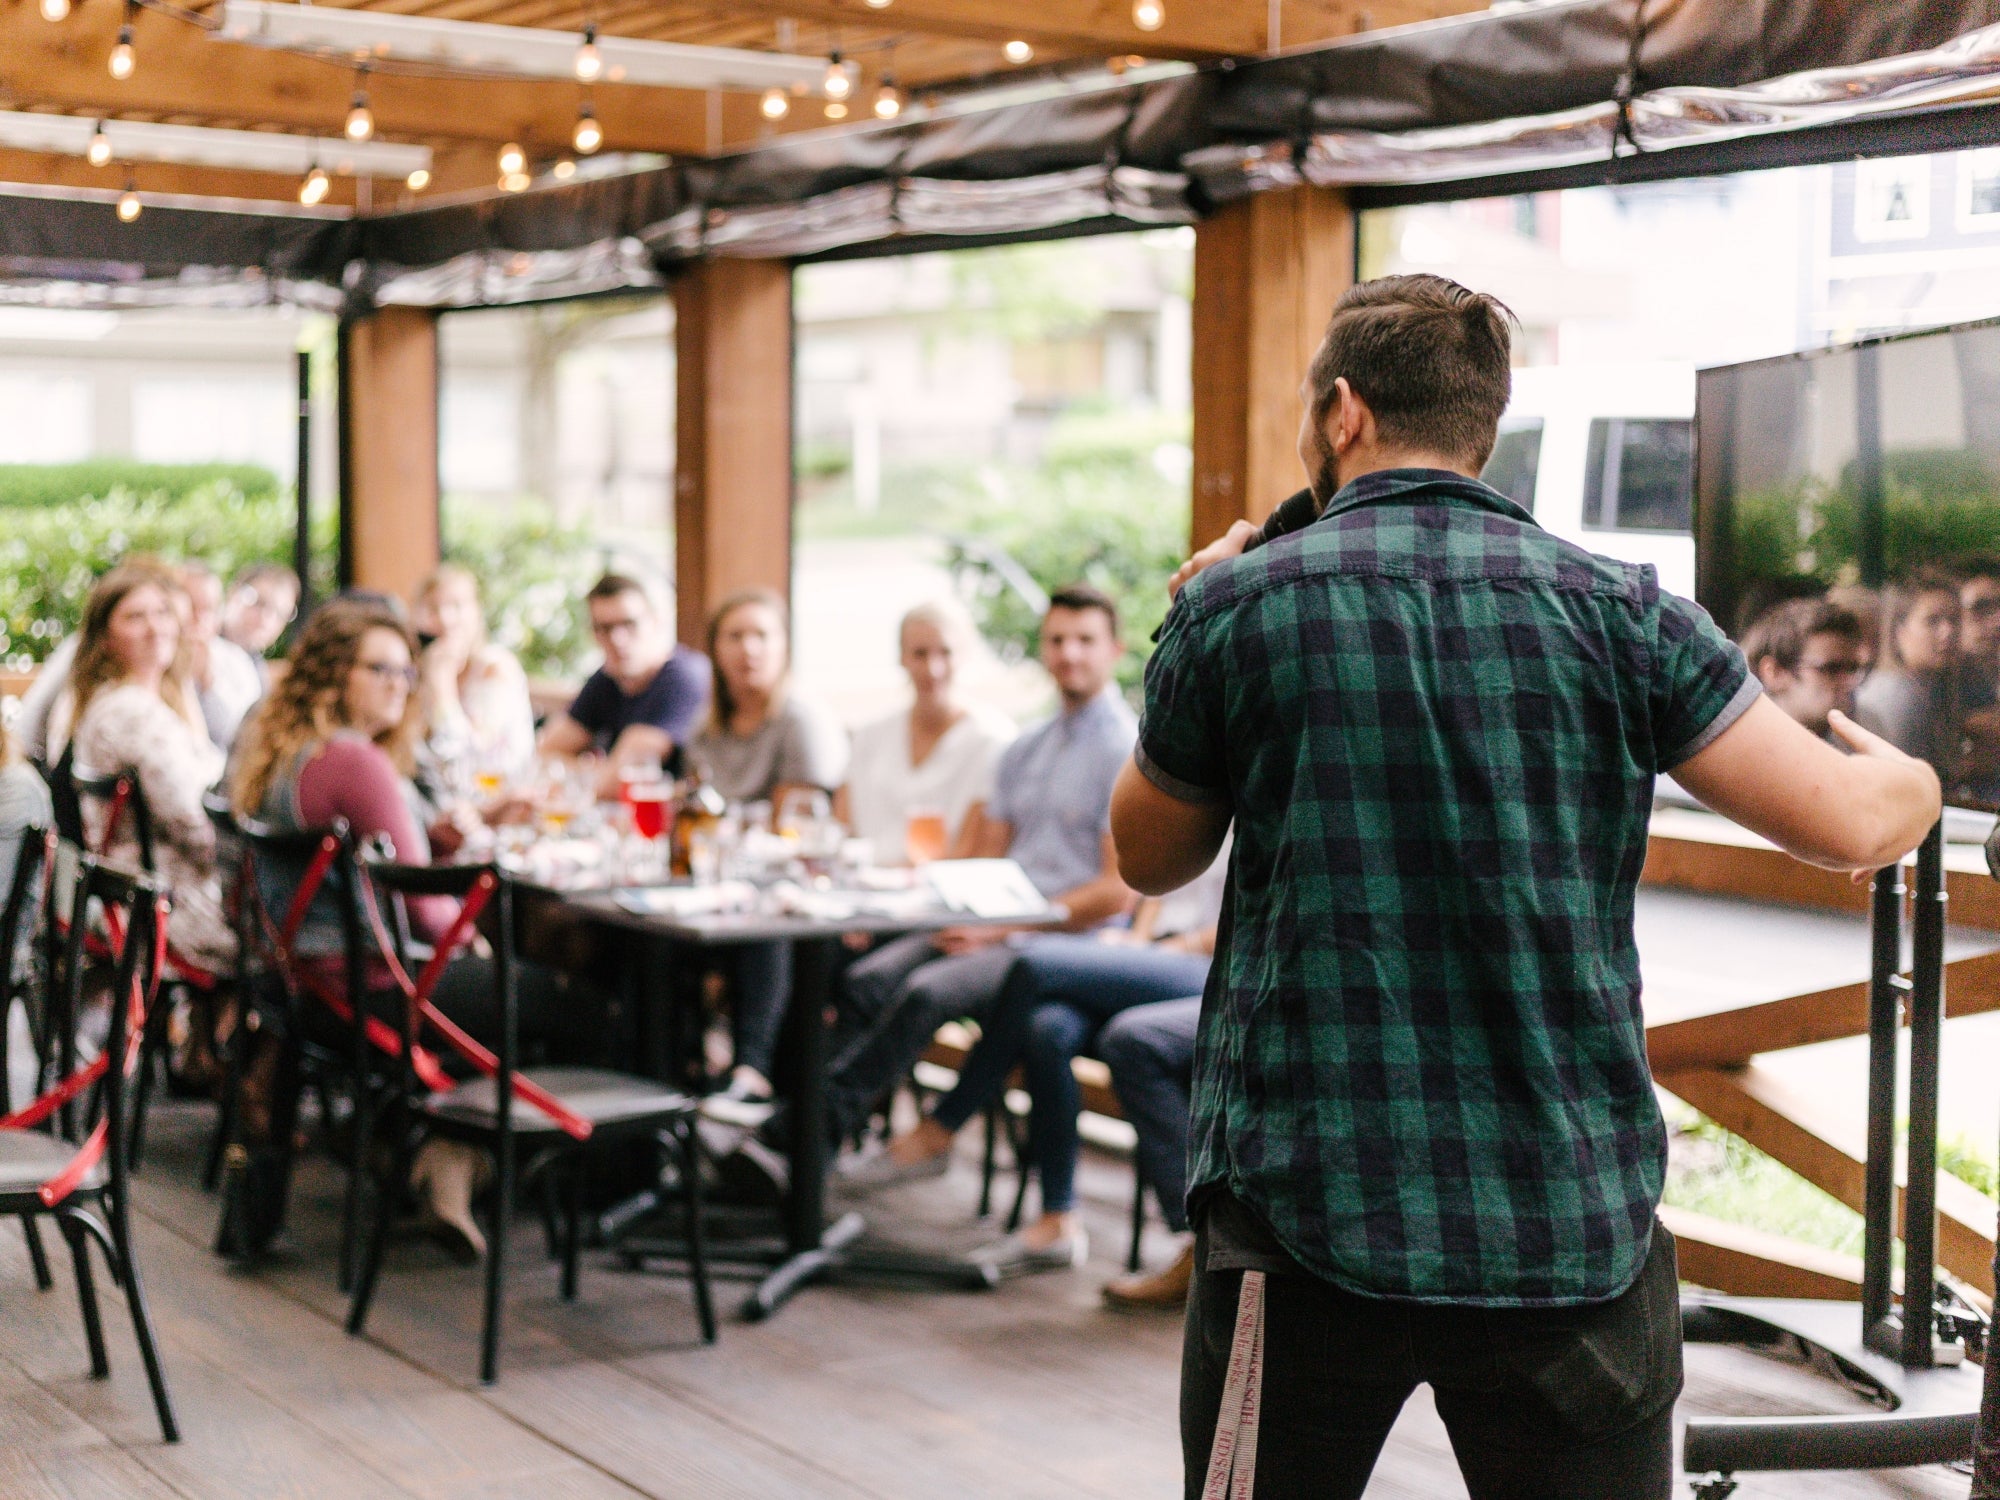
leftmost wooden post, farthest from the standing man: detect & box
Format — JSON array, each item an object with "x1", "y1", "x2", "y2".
[{"x1": 340, "y1": 308, "x2": 438, "y2": 598}]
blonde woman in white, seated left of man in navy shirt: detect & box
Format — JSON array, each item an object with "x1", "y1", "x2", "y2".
[{"x1": 410, "y1": 562, "x2": 534, "y2": 784}]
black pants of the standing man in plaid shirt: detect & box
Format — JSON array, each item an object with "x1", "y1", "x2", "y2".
[{"x1": 1180, "y1": 1226, "x2": 1680, "y2": 1500}]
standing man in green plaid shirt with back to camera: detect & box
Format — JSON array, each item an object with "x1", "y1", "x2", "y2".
[{"x1": 1112, "y1": 276, "x2": 1940, "y2": 1500}]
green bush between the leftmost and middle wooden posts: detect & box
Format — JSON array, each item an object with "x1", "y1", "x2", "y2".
[{"x1": 444, "y1": 496, "x2": 604, "y2": 678}]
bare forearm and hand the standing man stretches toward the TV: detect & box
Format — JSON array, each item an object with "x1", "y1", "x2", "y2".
[{"x1": 1670, "y1": 698, "x2": 1942, "y2": 872}]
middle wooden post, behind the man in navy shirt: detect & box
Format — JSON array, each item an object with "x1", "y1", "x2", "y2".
[{"x1": 674, "y1": 260, "x2": 792, "y2": 646}]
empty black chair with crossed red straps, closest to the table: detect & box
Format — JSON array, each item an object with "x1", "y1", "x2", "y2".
[{"x1": 348, "y1": 862, "x2": 716, "y2": 1384}]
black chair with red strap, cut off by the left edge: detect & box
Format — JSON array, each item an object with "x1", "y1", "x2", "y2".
[{"x1": 0, "y1": 856, "x2": 180, "y2": 1442}]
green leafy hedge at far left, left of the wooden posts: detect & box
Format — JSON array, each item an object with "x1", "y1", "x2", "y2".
[{"x1": 0, "y1": 482, "x2": 336, "y2": 670}]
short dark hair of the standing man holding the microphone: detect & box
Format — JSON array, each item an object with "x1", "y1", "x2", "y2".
[{"x1": 1308, "y1": 276, "x2": 1518, "y2": 468}]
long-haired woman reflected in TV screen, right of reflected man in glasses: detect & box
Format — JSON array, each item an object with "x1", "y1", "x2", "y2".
[{"x1": 1854, "y1": 570, "x2": 1964, "y2": 786}]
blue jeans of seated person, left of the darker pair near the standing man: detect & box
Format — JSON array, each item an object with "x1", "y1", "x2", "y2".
[{"x1": 932, "y1": 936, "x2": 1208, "y2": 1214}]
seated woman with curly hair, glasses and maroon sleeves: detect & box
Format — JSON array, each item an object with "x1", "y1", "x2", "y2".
[{"x1": 230, "y1": 598, "x2": 580, "y2": 1260}]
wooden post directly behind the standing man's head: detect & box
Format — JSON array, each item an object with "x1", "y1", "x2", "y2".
[{"x1": 1194, "y1": 188, "x2": 1354, "y2": 546}]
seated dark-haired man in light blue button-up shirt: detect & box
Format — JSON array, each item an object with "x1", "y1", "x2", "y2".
[{"x1": 828, "y1": 584, "x2": 1138, "y2": 1140}]
